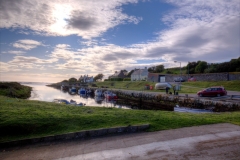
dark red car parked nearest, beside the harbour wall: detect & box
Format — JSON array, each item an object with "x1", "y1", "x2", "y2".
[{"x1": 197, "y1": 86, "x2": 227, "y2": 97}]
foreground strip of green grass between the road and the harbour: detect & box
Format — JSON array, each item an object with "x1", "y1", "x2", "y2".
[{"x1": 0, "y1": 96, "x2": 240, "y2": 142}]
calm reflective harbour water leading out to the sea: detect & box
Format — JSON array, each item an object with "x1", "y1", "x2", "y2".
[{"x1": 21, "y1": 82, "x2": 131, "y2": 109}]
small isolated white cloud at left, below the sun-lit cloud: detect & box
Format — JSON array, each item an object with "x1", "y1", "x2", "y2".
[{"x1": 13, "y1": 39, "x2": 43, "y2": 50}]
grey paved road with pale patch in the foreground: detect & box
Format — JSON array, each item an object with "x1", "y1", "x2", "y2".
[{"x1": 0, "y1": 123, "x2": 240, "y2": 160}]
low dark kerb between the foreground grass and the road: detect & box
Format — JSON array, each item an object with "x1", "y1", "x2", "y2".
[{"x1": 0, "y1": 124, "x2": 149, "y2": 148}]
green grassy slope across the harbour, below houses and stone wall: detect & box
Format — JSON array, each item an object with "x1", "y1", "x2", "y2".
[{"x1": 95, "y1": 80, "x2": 240, "y2": 93}]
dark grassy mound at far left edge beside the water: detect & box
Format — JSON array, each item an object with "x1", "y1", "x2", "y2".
[{"x1": 0, "y1": 82, "x2": 32, "y2": 99}]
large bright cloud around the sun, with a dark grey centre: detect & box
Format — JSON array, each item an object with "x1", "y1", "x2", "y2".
[{"x1": 0, "y1": 0, "x2": 142, "y2": 39}]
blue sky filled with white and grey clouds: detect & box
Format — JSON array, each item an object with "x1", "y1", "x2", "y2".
[{"x1": 0, "y1": 0, "x2": 240, "y2": 83}]
